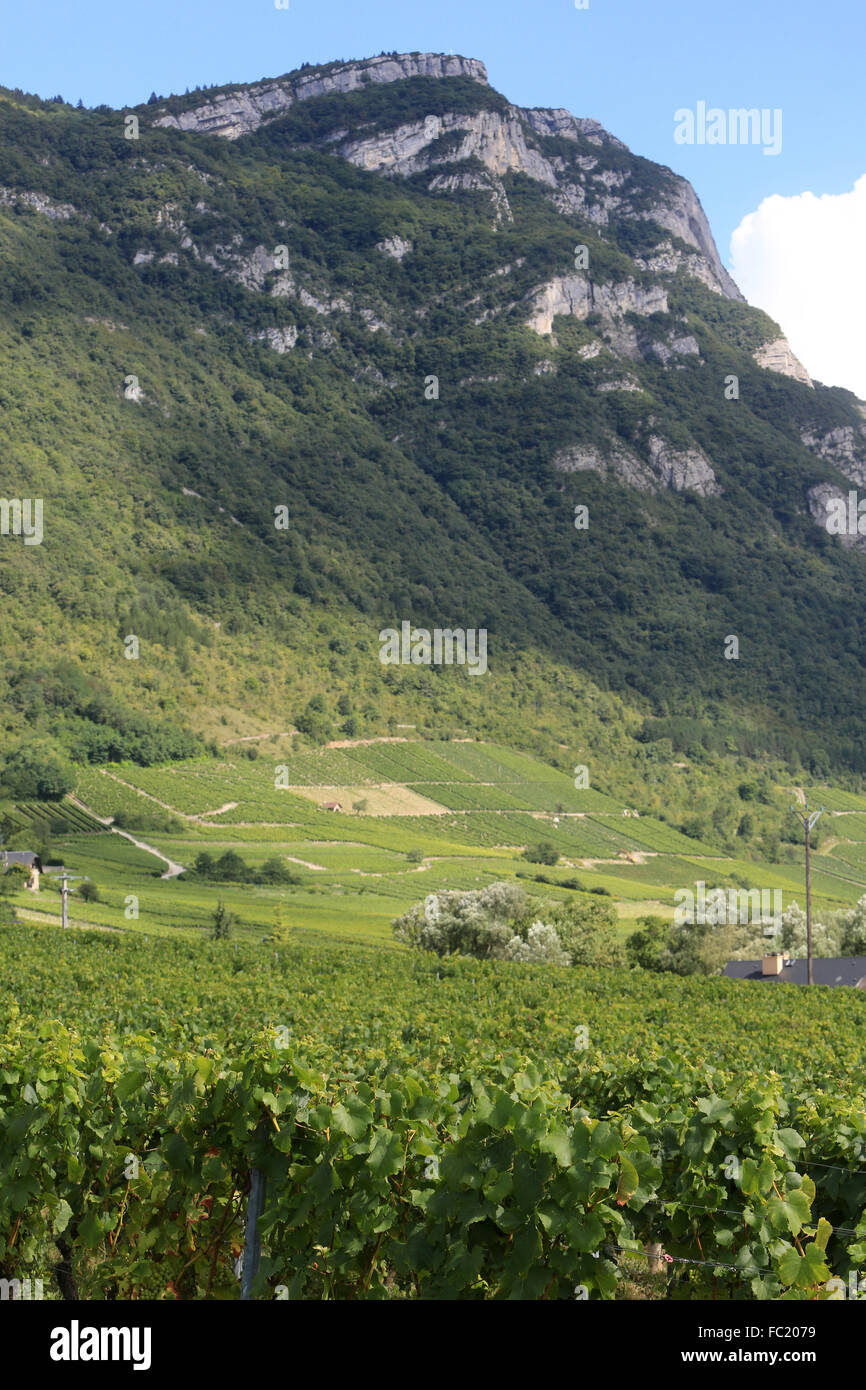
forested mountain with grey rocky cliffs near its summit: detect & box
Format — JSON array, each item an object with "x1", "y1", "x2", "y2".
[{"x1": 0, "y1": 53, "x2": 866, "y2": 785}]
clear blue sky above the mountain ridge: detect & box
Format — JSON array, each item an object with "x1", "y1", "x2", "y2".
[{"x1": 6, "y1": 0, "x2": 866, "y2": 391}]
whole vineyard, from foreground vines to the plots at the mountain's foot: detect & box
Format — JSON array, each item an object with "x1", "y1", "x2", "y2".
[{"x1": 8, "y1": 742, "x2": 866, "y2": 1301}]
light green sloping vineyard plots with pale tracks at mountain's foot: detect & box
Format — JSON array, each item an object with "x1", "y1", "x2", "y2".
[{"x1": 6, "y1": 741, "x2": 866, "y2": 942}]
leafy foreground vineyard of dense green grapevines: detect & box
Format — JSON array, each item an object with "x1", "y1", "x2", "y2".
[{"x1": 0, "y1": 927, "x2": 866, "y2": 1300}]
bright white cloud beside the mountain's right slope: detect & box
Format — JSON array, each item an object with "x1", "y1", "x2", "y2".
[{"x1": 731, "y1": 174, "x2": 866, "y2": 400}]
